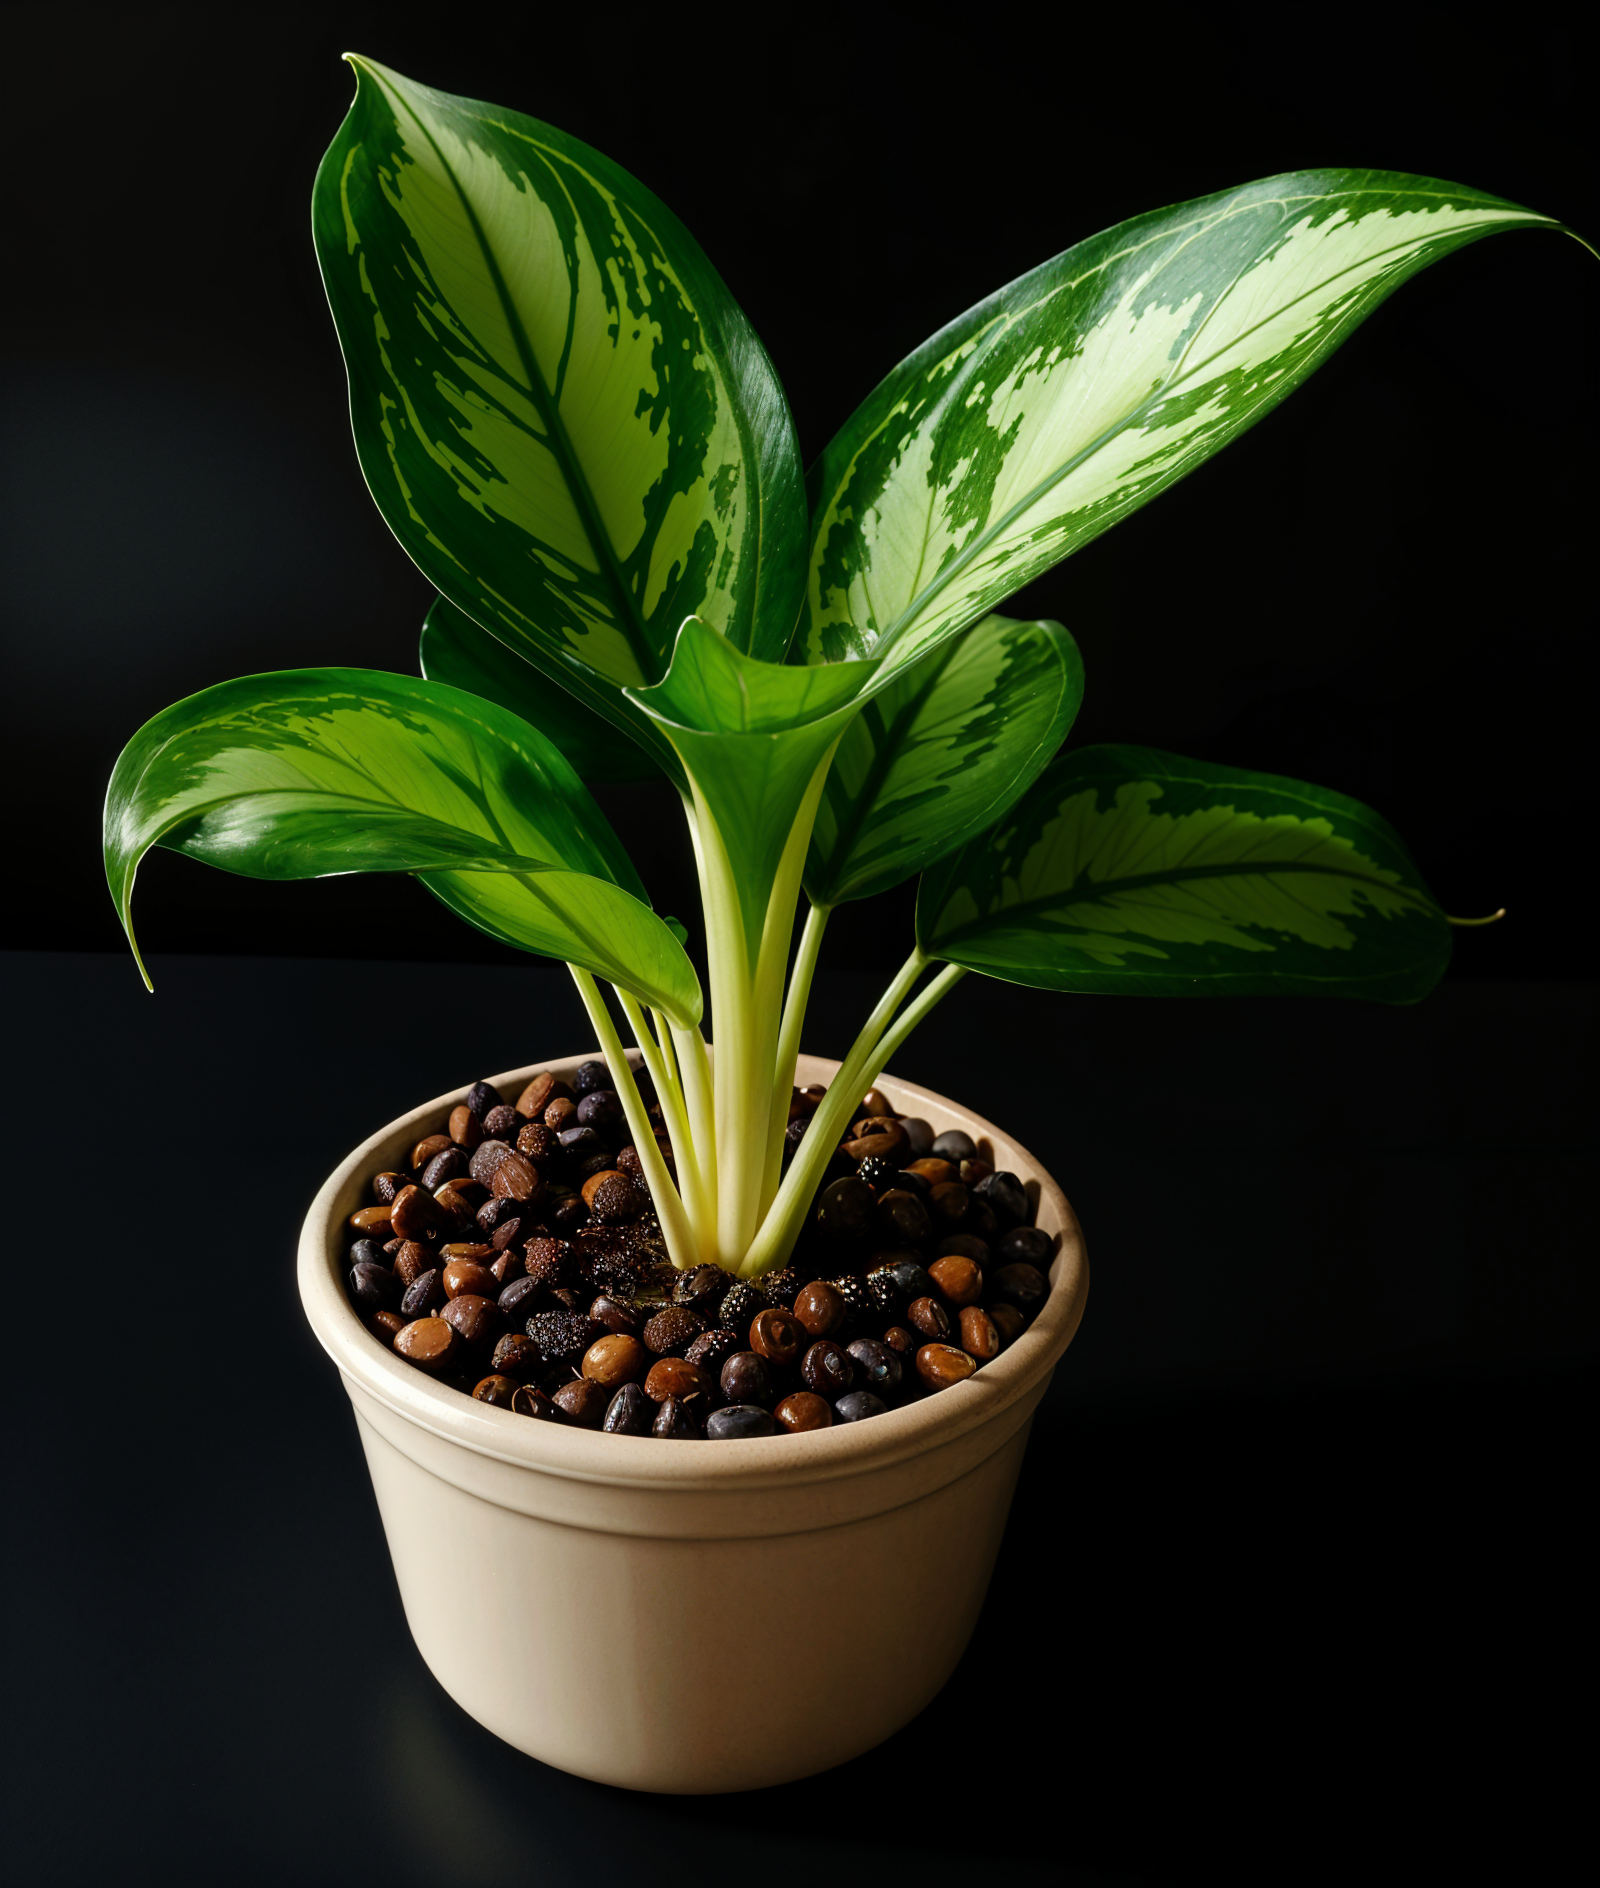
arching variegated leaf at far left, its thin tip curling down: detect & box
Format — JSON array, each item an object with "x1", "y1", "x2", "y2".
[{"x1": 106, "y1": 668, "x2": 699, "y2": 1021}]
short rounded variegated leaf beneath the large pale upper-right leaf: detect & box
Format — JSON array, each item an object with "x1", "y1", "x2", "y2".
[{"x1": 805, "y1": 615, "x2": 1082, "y2": 904}]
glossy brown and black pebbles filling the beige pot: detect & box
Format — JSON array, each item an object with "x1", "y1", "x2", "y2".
[{"x1": 346, "y1": 1061, "x2": 1054, "y2": 1441}]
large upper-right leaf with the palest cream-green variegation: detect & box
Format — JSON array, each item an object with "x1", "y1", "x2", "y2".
[{"x1": 795, "y1": 170, "x2": 1560, "y2": 666}]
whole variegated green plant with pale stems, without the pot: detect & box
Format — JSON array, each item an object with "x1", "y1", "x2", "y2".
[{"x1": 106, "y1": 59, "x2": 1586, "y2": 1276}]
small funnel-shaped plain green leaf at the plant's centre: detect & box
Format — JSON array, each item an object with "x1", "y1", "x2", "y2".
[{"x1": 629, "y1": 617, "x2": 873, "y2": 965}]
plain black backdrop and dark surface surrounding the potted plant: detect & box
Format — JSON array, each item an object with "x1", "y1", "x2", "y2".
[{"x1": 4, "y1": 6, "x2": 1600, "y2": 1884}]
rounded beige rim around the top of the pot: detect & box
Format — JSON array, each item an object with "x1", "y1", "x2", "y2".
[{"x1": 297, "y1": 1050, "x2": 1088, "y2": 1492}]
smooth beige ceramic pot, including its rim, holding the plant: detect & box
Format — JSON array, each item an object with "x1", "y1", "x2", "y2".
[{"x1": 298, "y1": 1050, "x2": 1088, "y2": 1794}]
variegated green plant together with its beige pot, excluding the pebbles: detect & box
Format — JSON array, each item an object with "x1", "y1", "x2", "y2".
[{"x1": 106, "y1": 59, "x2": 1586, "y2": 1790}]
